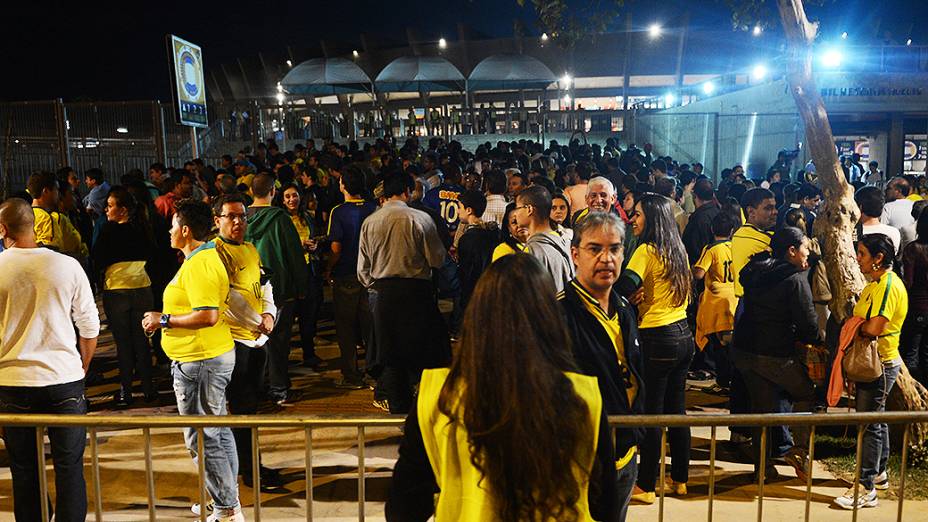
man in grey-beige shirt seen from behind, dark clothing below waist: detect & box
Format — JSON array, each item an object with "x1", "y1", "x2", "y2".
[{"x1": 358, "y1": 173, "x2": 451, "y2": 413}]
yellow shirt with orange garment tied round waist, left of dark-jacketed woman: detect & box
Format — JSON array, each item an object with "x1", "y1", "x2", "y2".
[{"x1": 693, "y1": 239, "x2": 738, "y2": 349}]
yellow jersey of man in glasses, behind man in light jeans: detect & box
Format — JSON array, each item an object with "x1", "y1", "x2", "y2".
[{"x1": 213, "y1": 237, "x2": 264, "y2": 341}]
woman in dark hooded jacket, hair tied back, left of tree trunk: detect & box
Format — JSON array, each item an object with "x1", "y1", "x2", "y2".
[{"x1": 731, "y1": 226, "x2": 819, "y2": 480}]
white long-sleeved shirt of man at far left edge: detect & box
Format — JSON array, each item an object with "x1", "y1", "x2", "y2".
[{"x1": 0, "y1": 247, "x2": 100, "y2": 387}]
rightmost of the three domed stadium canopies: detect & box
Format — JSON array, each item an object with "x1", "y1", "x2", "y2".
[{"x1": 467, "y1": 54, "x2": 557, "y2": 91}]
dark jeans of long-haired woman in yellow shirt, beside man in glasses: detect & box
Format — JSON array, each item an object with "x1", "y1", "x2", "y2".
[{"x1": 638, "y1": 319, "x2": 694, "y2": 491}]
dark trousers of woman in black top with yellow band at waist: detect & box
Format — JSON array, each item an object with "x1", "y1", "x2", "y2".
[{"x1": 103, "y1": 287, "x2": 154, "y2": 394}]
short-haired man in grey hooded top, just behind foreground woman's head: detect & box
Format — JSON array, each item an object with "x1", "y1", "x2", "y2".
[{"x1": 514, "y1": 185, "x2": 574, "y2": 292}]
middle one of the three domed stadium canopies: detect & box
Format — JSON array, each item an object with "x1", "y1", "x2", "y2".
[{"x1": 374, "y1": 56, "x2": 465, "y2": 92}]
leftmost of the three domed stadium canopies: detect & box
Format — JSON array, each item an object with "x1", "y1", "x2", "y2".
[{"x1": 280, "y1": 58, "x2": 371, "y2": 96}]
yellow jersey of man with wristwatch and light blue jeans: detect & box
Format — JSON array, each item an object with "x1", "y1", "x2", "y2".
[{"x1": 161, "y1": 242, "x2": 235, "y2": 362}]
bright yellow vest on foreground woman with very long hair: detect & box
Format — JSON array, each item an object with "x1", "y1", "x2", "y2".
[{"x1": 416, "y1": 368, "x2": 603, "y2": 522}]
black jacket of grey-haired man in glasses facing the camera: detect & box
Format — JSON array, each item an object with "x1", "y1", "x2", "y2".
[{"x1": 558, "y1": 280, "x2": 646, "y2": 457}]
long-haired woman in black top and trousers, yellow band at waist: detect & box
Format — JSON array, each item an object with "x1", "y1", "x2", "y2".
[{"x1": 91, "y1": 186, "x2": 158, "y2": 406}]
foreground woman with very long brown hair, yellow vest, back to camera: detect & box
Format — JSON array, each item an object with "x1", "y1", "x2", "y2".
[{"x1": 386, "y1": 254, "x2": 615, "y2": 522}]
